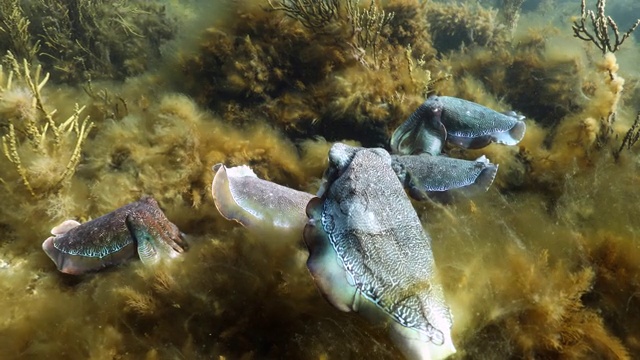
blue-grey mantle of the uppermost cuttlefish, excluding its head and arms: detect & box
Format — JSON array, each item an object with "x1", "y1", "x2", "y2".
[{"x1": 438, "y1": 96, "x2": 526, "y2": 149}]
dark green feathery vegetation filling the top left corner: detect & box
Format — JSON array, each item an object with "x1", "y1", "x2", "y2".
[{"x1": 0, "y1": 0, "x2": 177, "y2": 82}]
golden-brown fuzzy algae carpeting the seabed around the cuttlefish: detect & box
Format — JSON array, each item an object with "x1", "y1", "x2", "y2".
[{"x1": 0, "y1": 0, "x2": 640, "y2": 359}]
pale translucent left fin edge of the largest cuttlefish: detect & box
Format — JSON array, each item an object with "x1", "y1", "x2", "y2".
[{"x1": 304, "y1": 197, "x2": 357, "y2": 312}]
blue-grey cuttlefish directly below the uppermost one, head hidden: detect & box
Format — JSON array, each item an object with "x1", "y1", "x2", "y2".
[{"x1": 392, "y1": 154, "x2": 498, "y2": 200}]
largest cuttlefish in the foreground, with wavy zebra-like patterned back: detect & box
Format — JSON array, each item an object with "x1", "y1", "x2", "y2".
[{"x1": 304, "y1": 143, "x2": 455, "y2": 359}]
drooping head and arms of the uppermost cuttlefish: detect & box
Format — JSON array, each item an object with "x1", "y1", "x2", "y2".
[{"x1": 390, "y1": 97, "x2": 447, "y2": 155}]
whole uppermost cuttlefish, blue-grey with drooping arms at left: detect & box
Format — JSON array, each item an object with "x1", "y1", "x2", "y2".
[{"x1": 390, "y1": 96, "x2": 526, "y2": 155}]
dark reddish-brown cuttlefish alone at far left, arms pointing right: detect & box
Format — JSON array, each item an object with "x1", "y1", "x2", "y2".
[{"x1": 42, "y1": 197, "x2": 186, "y2": 275}]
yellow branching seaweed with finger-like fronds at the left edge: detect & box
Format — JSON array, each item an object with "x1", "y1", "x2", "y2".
[{"x1": 0, "y1": 53, "x2": 93, "y2": 197}]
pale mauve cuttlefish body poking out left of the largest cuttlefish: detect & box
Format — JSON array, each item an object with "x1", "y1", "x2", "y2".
[{"x1": 211, "y1": 164, "x2": 313, "y2": 234}]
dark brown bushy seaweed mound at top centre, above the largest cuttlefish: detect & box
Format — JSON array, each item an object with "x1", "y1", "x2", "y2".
[{"x1": 180, "y1": 1, "x2": 445, "y2": 146}]
